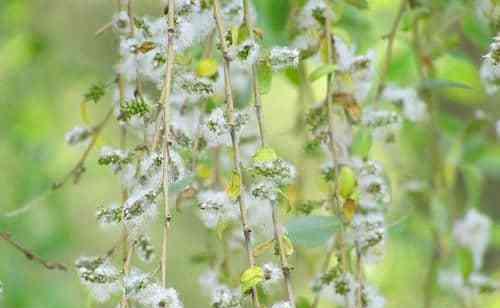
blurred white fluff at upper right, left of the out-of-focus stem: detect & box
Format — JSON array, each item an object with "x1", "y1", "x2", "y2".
[{"x1": 382, "y1": 85, "x2": 427, "y2": 122}]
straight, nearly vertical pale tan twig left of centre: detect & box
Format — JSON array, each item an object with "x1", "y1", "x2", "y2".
[{"x1": 160, "y1": 0, "x2": 175, "y2": 287}]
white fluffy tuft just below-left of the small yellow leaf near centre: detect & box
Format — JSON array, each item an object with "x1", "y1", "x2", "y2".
[{"x1": 198, "y1": 190, "x2": 239, "y2": 229}]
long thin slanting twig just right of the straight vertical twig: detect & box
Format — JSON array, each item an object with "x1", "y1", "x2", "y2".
[{"x1": 213, "y1": 0, "x2": 260, "y2": 308}]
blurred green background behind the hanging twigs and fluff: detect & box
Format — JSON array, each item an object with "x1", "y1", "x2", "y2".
[{"x1": 0, "y1": 0, "x2": 500, "y2": 308}]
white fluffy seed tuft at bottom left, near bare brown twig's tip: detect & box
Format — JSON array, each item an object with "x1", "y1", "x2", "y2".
[{"x1": 75, "y1": 257, "x2": 120, "y2": 302}]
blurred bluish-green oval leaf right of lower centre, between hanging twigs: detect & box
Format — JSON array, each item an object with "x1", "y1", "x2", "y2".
[{"x1": 286, "y1": 216, "x2": 340, "y2": 248}]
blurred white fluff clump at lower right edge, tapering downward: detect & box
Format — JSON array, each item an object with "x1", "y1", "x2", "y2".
[{"x1": 453, "y1": 209, "x2": 491, "y2": 270}]
